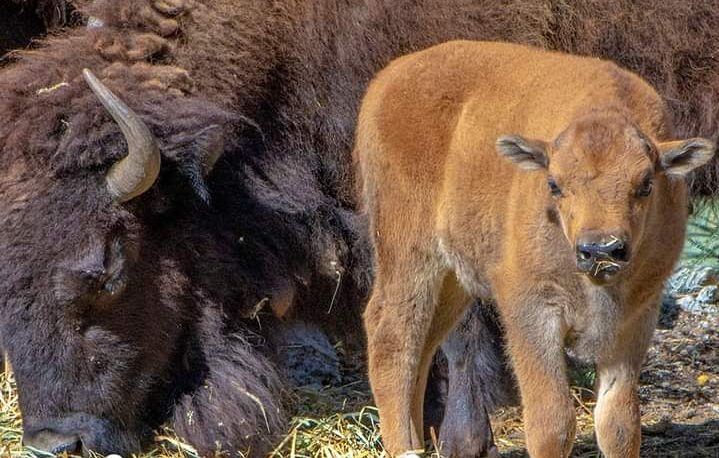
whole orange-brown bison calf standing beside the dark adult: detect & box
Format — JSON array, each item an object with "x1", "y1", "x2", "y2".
[{"x1": 355, "y1": 41, "x2": 714, "y2": 457}]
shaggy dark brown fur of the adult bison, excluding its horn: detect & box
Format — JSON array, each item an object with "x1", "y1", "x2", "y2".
[{"x1": 0, "y1": 0, "x2": 719, "y2": 455}]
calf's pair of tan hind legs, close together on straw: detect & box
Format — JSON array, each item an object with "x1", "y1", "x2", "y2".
[{"x1": 365, "y1": 263, "x2": 469, "y2": 456}]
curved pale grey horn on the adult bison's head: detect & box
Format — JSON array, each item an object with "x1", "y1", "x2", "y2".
[{"x1": 82, "y1": 69, "x2": 160, "y2": 202}]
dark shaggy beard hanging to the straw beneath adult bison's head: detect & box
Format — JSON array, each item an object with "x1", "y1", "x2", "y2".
[{"x1": 173, "y1": 309, "x2": 286, "y2": 457}]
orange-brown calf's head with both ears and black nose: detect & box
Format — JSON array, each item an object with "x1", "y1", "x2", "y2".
[{"x1": 497, "y1": 108, "x2": 714, "y2": 284}]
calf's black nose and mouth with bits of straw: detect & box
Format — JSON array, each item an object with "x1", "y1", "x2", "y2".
[{"x1": 576, "y1": 231, "x2": 630, "y2": 276}]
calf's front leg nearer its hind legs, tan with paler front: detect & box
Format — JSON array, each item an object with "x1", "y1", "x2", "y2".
[{"x1": 500, "y1": 294, "x2": 576, "y2": 458}]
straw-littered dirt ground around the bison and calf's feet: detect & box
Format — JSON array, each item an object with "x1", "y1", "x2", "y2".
[{"x1": 0, "y1": 296, "x2": 719, "y2": 458}]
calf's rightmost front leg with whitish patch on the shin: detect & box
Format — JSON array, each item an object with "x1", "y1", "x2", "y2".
[{"x1": 594, "y1": 307, "x2": 658, "y2": 458}]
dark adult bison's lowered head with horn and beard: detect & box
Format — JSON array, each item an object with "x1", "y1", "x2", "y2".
[{"x1": 0, "y1": 71, "x2": 279, "y2": 454}]
